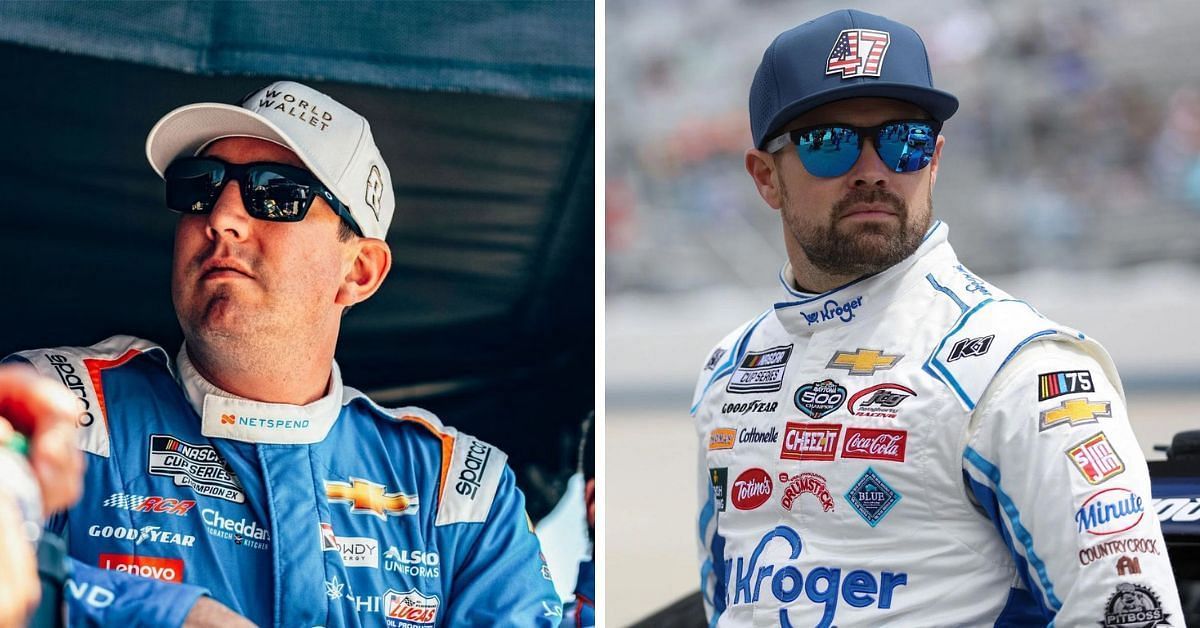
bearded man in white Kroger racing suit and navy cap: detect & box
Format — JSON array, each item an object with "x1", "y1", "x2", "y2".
[{"x1": 691, "y1": 11, "x2": 1183, "y2": 627}]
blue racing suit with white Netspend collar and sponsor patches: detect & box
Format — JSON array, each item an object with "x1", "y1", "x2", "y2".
[{"x1": 8, "y1": 336, "x2": 562, "y2": 628}]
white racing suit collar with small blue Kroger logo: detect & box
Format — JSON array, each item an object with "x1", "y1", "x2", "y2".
[{"x1": 775, "y1": 221, "x2": 954, "y2": 334}]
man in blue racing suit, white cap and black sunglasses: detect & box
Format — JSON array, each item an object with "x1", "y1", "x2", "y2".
[{"x1": 10, "y1": 82, "x2": 562, "y2": 628}]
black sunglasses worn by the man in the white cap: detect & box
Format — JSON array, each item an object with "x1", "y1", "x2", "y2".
[{"x1": 163, "y1": 157, "x2": 362, "y2": 235}]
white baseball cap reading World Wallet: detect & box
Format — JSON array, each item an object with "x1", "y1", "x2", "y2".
[{"x1": 146, "y1": 80, "x2": 396, "y2": 240}]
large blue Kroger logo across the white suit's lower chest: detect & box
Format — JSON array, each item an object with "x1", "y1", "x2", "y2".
[{"x1": 725, "y1": 526, "x2": 908, "y2": 627}]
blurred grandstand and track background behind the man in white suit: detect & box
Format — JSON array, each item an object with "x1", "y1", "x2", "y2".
[{"x1": 605, "y1": 0, "x2": 1200, "y2": 626}]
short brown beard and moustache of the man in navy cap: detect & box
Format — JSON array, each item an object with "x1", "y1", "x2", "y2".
[{"x1": 781, "y1": 187, "x2": 934, "y2": 277}]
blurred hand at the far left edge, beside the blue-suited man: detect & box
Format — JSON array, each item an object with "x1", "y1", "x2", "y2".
[{"x1": 0, "y1": 364, "x2": 84, "y2": 516}]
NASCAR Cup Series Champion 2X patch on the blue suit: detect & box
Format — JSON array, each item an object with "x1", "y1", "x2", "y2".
[{"x1": 146, "y1": 433, "x2": 246, "y2": 503}]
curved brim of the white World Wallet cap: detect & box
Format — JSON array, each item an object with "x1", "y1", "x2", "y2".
[{"x1": 146, "y1": 102, "x2": 330, "y2": 186}]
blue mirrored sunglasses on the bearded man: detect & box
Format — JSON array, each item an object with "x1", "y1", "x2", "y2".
[{"x1": 767, "y1": 120, "x2": 942, "y2": 177}]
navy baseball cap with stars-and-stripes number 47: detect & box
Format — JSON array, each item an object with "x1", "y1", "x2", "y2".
[{"x1": 750, "y1": 8, "x2": 959, "y2": 149}]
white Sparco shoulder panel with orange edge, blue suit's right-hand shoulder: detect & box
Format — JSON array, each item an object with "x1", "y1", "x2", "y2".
[{"x1": 344, "y1": 387, "x2": 511, "y2": 526}]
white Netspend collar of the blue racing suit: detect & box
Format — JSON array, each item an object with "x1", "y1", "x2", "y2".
[{"x1": 176, "y1": 345, "x2": 342, "y2": 444}]
